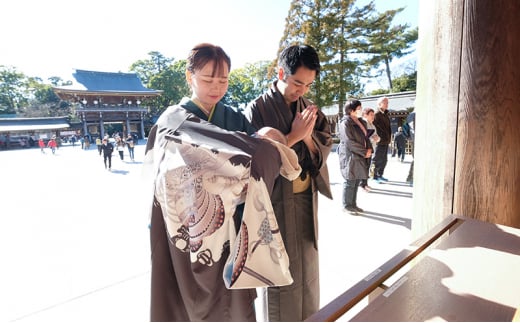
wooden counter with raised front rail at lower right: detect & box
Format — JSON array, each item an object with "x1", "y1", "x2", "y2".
[{"x1": 306, "y1": 215, "x2": 520, "y2": 322}]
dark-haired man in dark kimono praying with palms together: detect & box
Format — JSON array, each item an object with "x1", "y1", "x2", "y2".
[{"x1": 245, "y1": 46, "x2": 332, "y2": 321}]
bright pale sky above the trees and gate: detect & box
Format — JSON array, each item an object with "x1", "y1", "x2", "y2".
[{"x1": 0, "y1": 0, "x2": 419, "y2": 81}]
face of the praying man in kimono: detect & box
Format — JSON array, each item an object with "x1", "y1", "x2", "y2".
[{"x1": 277, "y1": 66, "x2": 316, "y2": 105}]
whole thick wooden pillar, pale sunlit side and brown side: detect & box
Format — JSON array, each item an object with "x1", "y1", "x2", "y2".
[{"x1": 413, "y1": 0, "x2": 520, "y2": 237}]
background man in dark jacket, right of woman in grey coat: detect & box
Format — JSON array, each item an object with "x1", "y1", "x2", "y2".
[{"x1": 372, "y1": 96, "x2": 392, "y2": 182}]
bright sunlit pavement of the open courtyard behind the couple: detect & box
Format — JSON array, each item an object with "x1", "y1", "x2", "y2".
[{"x1": 0, "y1": 142, "x2": 412, "y2": 323}]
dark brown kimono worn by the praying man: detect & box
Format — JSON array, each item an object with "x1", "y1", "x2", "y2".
[{"x1": 245, "y1": 82, "x2": 332, "y2": 321}]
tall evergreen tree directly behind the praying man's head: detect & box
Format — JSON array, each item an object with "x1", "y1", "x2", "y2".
[{"x1": 279, "y1": 0, "x2": 375, "y2": 115}]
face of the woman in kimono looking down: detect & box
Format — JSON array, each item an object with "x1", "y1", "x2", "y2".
[{"x1": 186, "y1": 61, "x2": 229, "y2": 108}]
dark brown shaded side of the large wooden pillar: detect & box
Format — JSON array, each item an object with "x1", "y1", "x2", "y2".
[{"x1": 453, "y1": 0, "x2": 520, "y2": 228}]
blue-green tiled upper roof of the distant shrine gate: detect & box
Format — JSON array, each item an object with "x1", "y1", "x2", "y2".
[{"x1": 57, "y1": 70, "x2": 160, "y2": 94}]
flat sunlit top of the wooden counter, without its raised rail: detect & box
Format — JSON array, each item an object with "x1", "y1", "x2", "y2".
[{"x1": 352, "y1": 217, "x2": 520, "y2": 322}]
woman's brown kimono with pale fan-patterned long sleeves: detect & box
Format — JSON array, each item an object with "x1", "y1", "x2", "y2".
[{"x1": 144, "y1": 106, "x2": 300, "y2": 321}]
